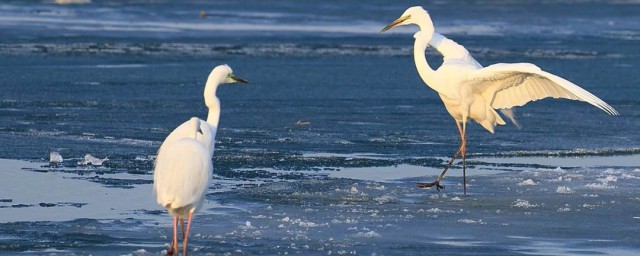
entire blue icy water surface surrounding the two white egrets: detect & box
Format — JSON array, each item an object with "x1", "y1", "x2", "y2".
[{"x1": 0, "y1": 0, "x2": 640, "y2": 255}]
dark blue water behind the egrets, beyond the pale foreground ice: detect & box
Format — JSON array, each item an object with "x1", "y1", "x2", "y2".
[{"x1": 0, "y1": 1, "x2": 640, "y2": 164}]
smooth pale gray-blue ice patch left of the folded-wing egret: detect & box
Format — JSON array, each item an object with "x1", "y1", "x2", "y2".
[{"x1": 0, "y1": 159, "x2": 219, "y2": 223}]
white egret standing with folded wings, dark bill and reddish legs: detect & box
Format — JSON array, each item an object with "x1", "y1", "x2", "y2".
[{"x1": 153, "y1": 65, "x2": 247, "y2": 255}]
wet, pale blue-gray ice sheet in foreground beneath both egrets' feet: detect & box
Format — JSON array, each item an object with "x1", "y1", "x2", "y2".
[{"x1": 0, "y1": 155, "x2": 640, "y2": 255}]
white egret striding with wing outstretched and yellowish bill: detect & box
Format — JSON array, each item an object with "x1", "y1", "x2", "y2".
[{"x1": 380, "y1": 6, "x2": 618, "y2": 194}]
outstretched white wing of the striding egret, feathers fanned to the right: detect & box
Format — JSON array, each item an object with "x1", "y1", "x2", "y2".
[{"x1": 468, "y1": 63, "x2": 618, "y2": 115}]
